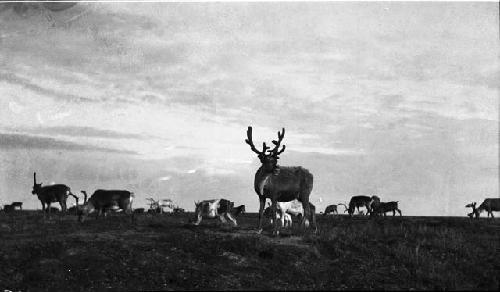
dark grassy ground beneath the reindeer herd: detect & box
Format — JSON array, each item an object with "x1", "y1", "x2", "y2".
[{"x1": 0, "y1": 212, "x2": 500, "y2": 291}]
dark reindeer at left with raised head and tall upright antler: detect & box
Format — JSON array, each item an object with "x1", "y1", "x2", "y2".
[{"x1": 31, "y1": 172, "x2": 73, "y2": 214}]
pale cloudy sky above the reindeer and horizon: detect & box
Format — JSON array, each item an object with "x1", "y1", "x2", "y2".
[{"x1": 0, "y1": 2, "x2": 500, "y2": 216}]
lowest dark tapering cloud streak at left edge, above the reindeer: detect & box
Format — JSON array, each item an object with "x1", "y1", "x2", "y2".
[{"x1": 0, "y1": 133, "x2": 136, "y2": 154}]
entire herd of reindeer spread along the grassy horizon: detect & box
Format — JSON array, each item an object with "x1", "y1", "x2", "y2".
[{"x1": 0, "y1": 126, "x2": 500, "y2": 235}]
